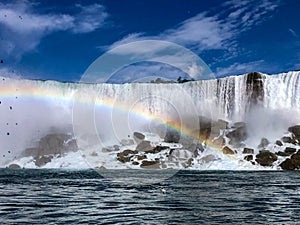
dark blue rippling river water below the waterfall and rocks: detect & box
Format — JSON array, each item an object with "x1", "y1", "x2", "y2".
[{"x1": 0, "y1": 169, "x2": 300, "y2": 224}]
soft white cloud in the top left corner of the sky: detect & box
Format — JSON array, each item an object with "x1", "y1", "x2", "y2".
[{"x1": 0, "y1": 0, "x2": 108, "y2": 58}]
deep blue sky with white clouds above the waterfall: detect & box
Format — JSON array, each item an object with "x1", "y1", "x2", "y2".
[{"x1": 0, "y1": 0, "x2": 300, "y2": 81}]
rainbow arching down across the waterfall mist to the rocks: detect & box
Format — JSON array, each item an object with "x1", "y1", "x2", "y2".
[{"x1": 0, "y1": 79, "x2": 236, "y2": 161}]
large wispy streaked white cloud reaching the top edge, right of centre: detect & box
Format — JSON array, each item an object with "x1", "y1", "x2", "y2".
[{"x1": 111, "y1": 0, "x2": 279, "y2": 56}]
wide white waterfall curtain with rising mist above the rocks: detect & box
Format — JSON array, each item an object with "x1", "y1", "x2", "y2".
[{"x1": 0, "y1": 72, "x2": 300, "y2": 166}]
